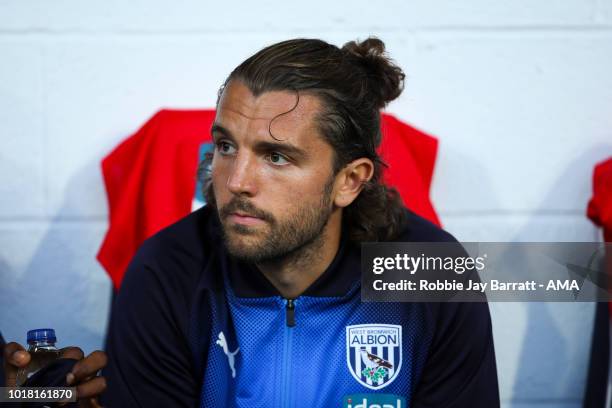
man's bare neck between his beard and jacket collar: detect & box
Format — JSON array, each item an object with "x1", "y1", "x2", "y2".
[{"x1": 257, "y1": 213, "x2": 341, "y2": 299}]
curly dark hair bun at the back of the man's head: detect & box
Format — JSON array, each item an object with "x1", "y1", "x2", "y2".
[{"x1": 342, "y1": 37, "x2": 406, "y2": 108}]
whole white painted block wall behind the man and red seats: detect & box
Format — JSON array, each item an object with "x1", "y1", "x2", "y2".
[{"x1": 0, "y1": 0, "x2": 612, "y2": 408}]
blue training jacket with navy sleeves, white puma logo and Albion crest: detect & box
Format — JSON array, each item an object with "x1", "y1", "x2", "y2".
[{"x1": 102, "y1": 207, "x2": 499, "y2": 408}]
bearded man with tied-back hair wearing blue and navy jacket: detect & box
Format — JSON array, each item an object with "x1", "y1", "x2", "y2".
[{"x1": 103, "y1": 38, "x2": 499, "y2": 408}]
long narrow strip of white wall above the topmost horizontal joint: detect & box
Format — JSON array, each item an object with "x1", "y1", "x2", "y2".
[{"x1": 0, "y1": 0, "x2": 609, "y2": 33}]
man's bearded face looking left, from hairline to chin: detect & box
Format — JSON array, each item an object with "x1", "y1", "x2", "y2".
[{"x1": 212, "y1": 81, "x2": 334, "y2": 262}]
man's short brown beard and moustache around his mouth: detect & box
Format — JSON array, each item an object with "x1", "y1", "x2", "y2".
[{"x1": 208, "y1": 177, "x2": 334, "y2": 263}]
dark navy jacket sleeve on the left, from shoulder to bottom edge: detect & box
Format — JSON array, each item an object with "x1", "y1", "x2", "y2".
[{"x1": 103, "y1": 209, "x2": 215, "y2": 406}]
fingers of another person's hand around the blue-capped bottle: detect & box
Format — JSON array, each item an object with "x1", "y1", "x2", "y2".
[{"x1": 4, "y1": 342, "x2": 106, "y2": 408}]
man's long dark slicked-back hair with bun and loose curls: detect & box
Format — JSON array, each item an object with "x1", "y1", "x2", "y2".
[{"x1": 205, "y1": 38, "x2": 406, "y2": 242}]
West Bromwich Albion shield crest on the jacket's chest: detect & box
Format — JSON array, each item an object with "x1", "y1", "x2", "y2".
[{"x1": 346, "y1": 324, "x2": 402, "y2": 390}]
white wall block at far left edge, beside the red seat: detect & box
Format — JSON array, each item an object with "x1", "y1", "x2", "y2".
[{"x1": 0, "y1": 38, "x2": 45, "y2": 218}]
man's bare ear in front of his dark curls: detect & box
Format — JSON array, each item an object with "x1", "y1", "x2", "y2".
[{"x1": 334, "y1": 157, "x2": 374, "y2": 207}]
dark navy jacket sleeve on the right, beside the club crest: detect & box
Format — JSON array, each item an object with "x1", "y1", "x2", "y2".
[{"x1": 395, "y1": 210, "x2": 499, "y2": 408}]
